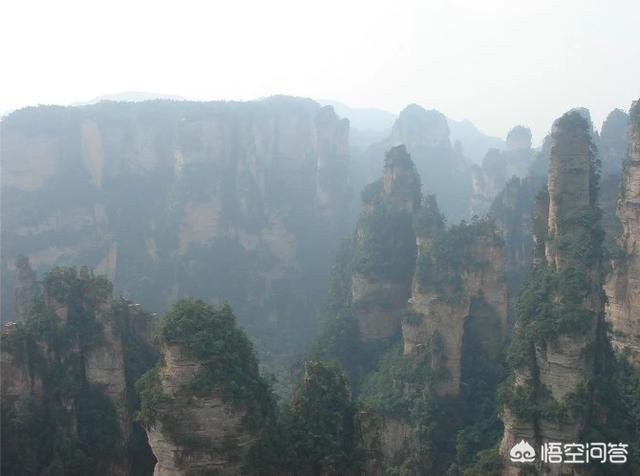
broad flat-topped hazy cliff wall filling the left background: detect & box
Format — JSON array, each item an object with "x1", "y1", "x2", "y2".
[{"x1": 0, "y1": 97, "x2": 349, "y2": 372}]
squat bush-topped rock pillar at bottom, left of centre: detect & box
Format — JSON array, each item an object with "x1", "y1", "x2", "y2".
[{"x1": 138, "y1": 300, "x2": 273, "y2": 476}]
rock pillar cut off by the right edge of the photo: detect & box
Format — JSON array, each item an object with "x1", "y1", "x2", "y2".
[{"x1": 606, "y1": 101, "x2": 640, "y2": 367}]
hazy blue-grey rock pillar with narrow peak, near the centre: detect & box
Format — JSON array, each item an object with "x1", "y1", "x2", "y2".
[{"x1": 351, "y1": 146, "x2": 420, "y2": 341}]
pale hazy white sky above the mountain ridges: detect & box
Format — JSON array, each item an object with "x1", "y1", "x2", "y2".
[{"x1": 0, "y1": 0, "x2": 640, "y2": 143}]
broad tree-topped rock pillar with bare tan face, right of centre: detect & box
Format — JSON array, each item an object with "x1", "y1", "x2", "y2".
[{"x1": 402, "y1": 225, "x2": 508, "y2": 396}]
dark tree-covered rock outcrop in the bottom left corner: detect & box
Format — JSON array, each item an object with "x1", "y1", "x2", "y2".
[{"x1": 0, "y1": 261, "x2": 157, "y2": 474}]
